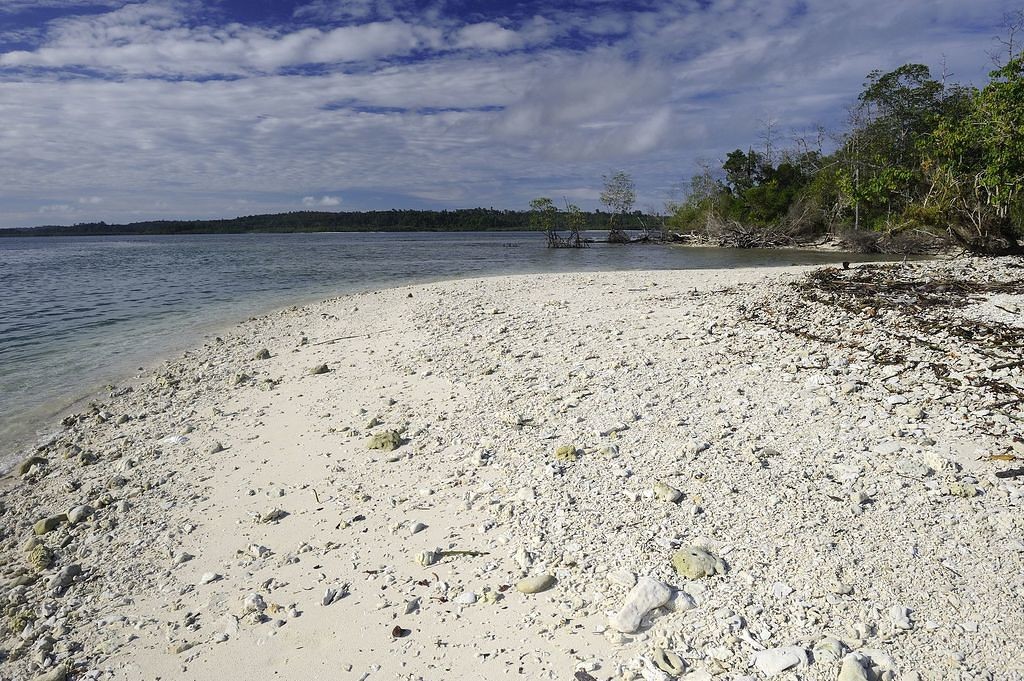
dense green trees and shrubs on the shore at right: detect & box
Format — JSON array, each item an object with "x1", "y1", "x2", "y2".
[{"x1": 668, "y1": 29, "x2": 1024, "y2": 254}]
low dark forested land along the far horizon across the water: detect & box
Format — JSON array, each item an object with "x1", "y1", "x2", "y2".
[{"x1": 0, "y1": 208, "x2": 647, "y2": 237}]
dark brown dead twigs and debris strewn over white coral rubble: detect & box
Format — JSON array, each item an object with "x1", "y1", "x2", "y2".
[{"x1": 742, "y1": 259, "x2": 1024, "y2": 448}]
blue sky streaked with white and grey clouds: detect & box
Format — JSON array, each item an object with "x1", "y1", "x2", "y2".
[{"x1": 0, "y1": 0, "x2": 1021, "y2": 227}]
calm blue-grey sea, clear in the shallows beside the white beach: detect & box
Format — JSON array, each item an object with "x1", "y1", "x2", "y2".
[{"x1": 0, "y1": 232, "x2": 880, "y2": 469}]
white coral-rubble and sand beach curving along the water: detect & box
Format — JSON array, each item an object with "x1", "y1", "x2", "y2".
[{"x1": 0, "y1": 260, "x2": 1024, "y2": 681}]
